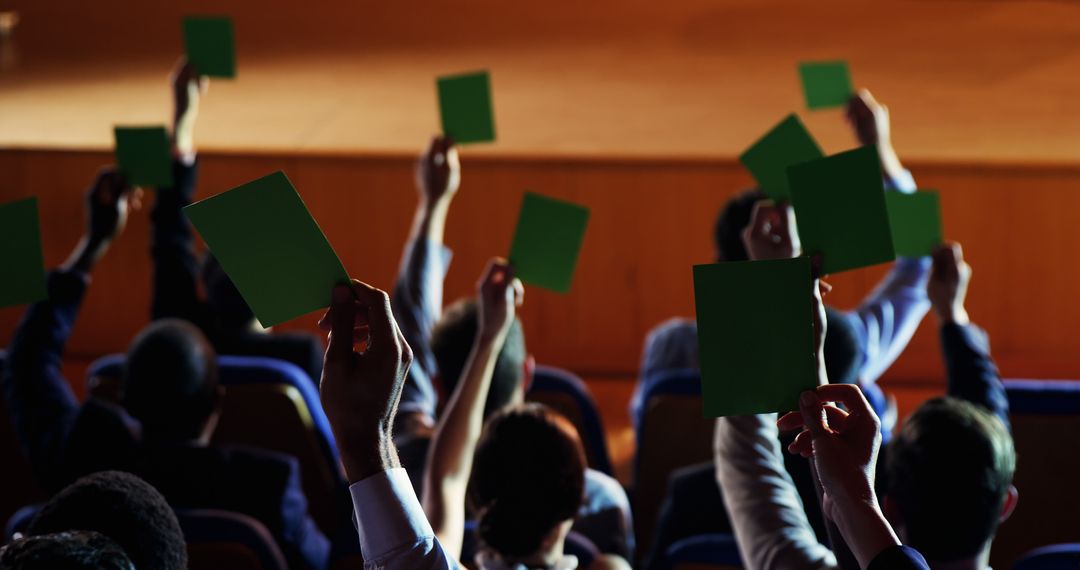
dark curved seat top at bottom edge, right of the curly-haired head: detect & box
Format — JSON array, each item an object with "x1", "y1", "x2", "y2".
[{"x1": 176, "y1": 510, "x2": 288, "y2": 570}]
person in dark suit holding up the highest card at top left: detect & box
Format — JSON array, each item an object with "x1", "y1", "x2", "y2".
[{"x1": 150, "y1": 57, "x2": 323, "y2": 382}]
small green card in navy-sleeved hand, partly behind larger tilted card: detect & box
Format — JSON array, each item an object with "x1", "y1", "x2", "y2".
[{"x1": 885, "y1": 191, "x2": 942, "y2": 257}]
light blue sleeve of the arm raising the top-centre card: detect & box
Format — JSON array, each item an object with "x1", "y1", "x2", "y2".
[{"x1": 391, "y1": 240, "x2": 453, "y2": 418}]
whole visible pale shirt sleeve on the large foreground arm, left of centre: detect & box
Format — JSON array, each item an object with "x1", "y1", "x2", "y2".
[{"x1": 349, "y1": 467, "x2": 460, "y2": 570}]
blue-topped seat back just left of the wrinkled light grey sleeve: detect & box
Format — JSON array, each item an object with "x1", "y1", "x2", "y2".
[{"x1": 632, "y1": 370, "x2": 715, "y2": 565}]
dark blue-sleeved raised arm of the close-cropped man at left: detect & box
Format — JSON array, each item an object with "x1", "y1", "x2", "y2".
[{"x1": 3, "y1": 168, "x2": 134, "y2": 486}]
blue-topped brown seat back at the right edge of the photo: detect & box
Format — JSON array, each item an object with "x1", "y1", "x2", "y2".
[{"x1": 990, "y1": 380, "x2": 1080, "y2": 568}]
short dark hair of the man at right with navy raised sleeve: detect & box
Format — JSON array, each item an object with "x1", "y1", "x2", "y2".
[{"x1": 887, "y1": 397, "x2": 1016, "y2": 562}]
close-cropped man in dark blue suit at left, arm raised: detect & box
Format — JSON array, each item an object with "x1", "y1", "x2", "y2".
[{"x1": 0, "y1": 168, "x2": 329, "y2": 568}]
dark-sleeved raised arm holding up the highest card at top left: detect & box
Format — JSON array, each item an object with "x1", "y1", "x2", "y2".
[{"x1": 150, "y1": 59, "x2": 211, "y2": 330}]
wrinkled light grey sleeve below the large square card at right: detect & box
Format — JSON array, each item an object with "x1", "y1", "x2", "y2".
[{"x1": 714, "y1": 413, "x2": 837, "y2": 569}]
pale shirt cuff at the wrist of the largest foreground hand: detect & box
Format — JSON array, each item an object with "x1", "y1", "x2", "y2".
[{"x1": 349, "y1": 467, "x2": 435, "y2": 560}]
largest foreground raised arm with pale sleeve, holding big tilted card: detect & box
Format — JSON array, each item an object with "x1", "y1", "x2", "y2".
[{"x1": 320, "y1": 281, "x2": 459, "y2": 570}]
